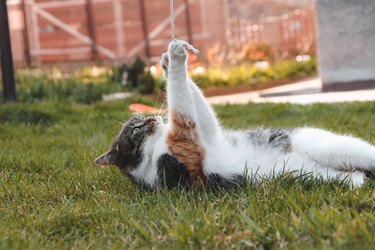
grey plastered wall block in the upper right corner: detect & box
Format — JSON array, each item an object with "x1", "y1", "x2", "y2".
[{"x1": 317, "y1": 0, "x2": 375, "y2": 90}]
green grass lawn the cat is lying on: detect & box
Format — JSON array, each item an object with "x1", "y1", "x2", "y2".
[{"x1": 0, "y1": 102, "x2": 375, "y2": 249}]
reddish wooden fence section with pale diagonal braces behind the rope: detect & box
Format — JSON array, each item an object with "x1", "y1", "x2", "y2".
[{"x1": 8, "y1": 0, "x2": 217, "y2": 64}]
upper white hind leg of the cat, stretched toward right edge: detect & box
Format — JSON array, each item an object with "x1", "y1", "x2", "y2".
[{"x1": 291, "y1": 128, "x2": 375, "y2": 171}]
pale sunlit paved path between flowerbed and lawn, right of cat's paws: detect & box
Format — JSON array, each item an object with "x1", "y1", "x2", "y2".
[{"x1": 207, "y1": 78, "x2": 375, "y2": 105}]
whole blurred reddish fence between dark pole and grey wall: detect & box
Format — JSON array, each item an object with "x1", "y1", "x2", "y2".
[{"x1": 8, "y1": 0, "x2": 316, "y2": 66}]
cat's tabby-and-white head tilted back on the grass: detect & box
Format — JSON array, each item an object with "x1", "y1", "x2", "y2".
[{"x1": 94, "y1": 116, "x2": 166, "y2": 187}]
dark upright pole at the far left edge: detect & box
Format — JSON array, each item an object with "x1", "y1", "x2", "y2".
[{"x1": 0, "y1": 0, "x2": 16, "y2": 102}]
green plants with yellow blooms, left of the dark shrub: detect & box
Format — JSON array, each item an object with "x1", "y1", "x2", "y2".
[{"x1": 1, "y1": 67, "x2": 123, "y2": 104}]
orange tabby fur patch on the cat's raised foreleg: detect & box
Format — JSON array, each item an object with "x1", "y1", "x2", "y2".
[{"x1": 167, "y1": 110, "x2": 207, "y2": 187}]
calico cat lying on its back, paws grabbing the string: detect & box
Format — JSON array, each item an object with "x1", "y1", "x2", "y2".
[{"x1": 94, "y1": 40, "x2": 375, "y2": 188}]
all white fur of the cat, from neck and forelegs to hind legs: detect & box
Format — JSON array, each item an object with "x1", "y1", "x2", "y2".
[{"x1": 137, "y1": 41, "x2": 375, "y2": 187}]
